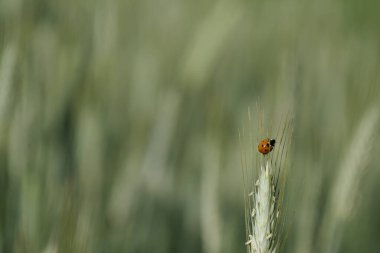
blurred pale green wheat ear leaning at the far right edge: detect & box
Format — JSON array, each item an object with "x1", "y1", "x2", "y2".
[{"x1": 318, "y1": 107, "x2": 379, "y2": 253}]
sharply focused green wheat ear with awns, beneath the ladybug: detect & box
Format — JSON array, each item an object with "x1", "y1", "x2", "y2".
[{"x1": 239, "y1": 111, "x2": 293, "y2": 253}]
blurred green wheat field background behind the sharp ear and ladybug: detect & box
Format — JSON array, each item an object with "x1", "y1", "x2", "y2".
[{"x1": 0, "y1": 0, "x2": 380, "y2": 253}]
